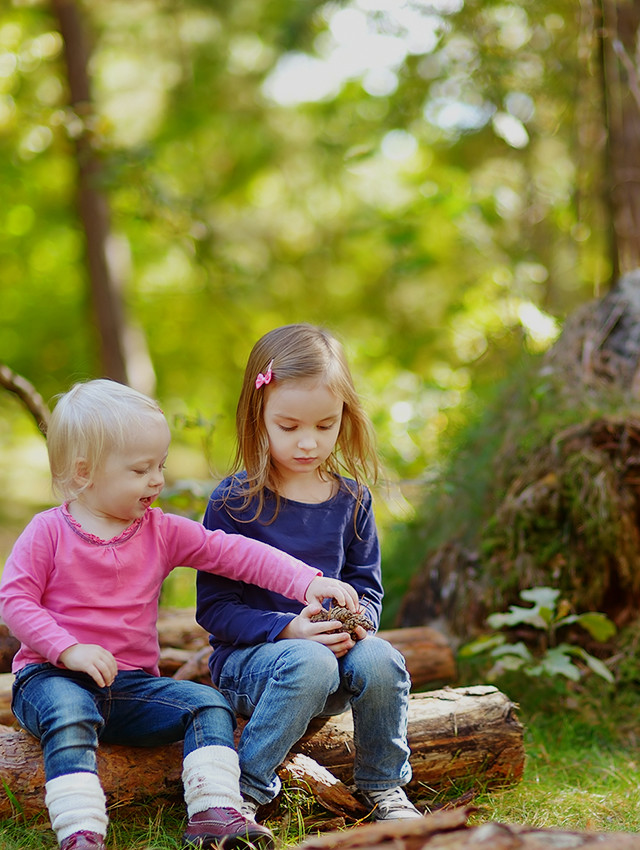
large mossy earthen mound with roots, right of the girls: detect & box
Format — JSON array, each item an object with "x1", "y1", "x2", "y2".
[{"x1": 397, "y1": 270, "x2": 640, "y2": 642}]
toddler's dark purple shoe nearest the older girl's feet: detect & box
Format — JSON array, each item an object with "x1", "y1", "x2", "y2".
[{"x1": 182, "y1": 808, "x2": 273, "y2": 850}]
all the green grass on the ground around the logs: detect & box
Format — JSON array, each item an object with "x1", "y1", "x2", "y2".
[{"x1": 0, "y1": 676, "x2": 640, "y2": 850}]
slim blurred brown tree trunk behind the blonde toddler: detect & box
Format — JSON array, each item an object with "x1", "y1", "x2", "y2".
[{"x1": 51, "y1": 0, "x2": 155, "y2": 393}]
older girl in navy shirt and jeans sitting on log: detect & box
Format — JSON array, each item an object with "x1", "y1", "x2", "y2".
[{"x1": 197, "y1": 324, "x2": 420, "y2": 820}]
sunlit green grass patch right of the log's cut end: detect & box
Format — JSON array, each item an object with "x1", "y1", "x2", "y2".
[{"x1": 462, "y1": 676, "x2": 640, "y2": 832}]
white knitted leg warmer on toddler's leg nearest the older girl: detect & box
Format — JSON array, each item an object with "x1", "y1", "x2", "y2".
[{"x1": 182, "y1": 745, "x2": 242, "y2": 817}]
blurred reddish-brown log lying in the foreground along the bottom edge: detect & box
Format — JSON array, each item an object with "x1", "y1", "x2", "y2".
[{"x1": 297, "y1": 807, "x2": 640, "y2": 850}]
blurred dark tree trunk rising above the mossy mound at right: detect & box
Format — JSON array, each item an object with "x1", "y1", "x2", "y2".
[{"x1": 598, "y1": 0, "x2": 640, "y2": 280}]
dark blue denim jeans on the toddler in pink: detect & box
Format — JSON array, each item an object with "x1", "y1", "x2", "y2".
[{"x1": 12, "y1": 664, "x2": 235, "y2": 781}]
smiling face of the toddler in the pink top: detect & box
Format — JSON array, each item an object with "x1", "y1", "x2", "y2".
[{"x1": 79, "y1": 414, "x2": 171, "y2": 523}]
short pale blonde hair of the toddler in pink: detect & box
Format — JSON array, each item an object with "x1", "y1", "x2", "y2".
[{"x1": 47, "y1": 379, "x2": 163, "y2": 501}]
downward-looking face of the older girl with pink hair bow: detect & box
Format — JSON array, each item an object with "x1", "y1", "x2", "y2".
[{"x1": 264, "y1": 378, "x2": 343, "y2": 481}]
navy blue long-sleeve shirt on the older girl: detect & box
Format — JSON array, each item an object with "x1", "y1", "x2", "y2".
[{"x1": 196, "y1": 473, "x2": 383, "y2": 683}]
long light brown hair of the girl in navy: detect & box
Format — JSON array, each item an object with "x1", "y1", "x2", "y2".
[{"x1": 233, "y1": 324, "x2": 379, "y2": 519}]
